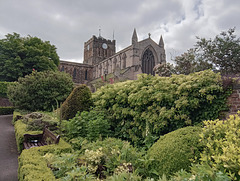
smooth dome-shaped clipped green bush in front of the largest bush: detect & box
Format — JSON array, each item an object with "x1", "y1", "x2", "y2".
[{"x1": 147, "y1": 126, "x2": 203, "y2": 177}]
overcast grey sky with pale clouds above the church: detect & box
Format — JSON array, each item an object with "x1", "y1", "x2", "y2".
[{"x1": 0, "y1": 0, "x2": 240, "y2": 62}]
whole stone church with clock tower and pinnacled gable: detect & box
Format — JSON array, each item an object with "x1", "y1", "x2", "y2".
[{"x1": 59, "y1": 29, "x2": 166, "y2": 85}]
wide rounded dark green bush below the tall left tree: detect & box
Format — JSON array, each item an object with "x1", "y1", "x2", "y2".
[{"x1": 8, "y1": 71, "x2": 73, "y2": 111}]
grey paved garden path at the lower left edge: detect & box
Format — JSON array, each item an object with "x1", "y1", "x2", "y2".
[{"x1": 0, "y1": 115, "x2": 18, "y2": 181}]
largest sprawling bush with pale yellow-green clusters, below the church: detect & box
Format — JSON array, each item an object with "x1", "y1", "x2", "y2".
[{"x1": 93, "y1": 70, "x2": 229, "y2": 147}]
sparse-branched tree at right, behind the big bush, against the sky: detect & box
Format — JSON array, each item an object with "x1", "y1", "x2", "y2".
[{"x1": 173, "y1": 28, "x2": 240, "y2": 75}]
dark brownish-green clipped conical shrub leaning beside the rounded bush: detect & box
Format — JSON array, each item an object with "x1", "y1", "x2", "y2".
[{"x1": 61, "y1": 85, "x2": 92, "y2": 120}]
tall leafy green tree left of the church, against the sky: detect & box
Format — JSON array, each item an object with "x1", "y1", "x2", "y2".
[{"x1": 0, "y1": 33, "x2": 59, "y2": 82}]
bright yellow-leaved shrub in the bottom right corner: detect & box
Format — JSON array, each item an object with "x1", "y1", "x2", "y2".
[{"x1": 200, "y1": 114, "x2": 240, "y2": 180}]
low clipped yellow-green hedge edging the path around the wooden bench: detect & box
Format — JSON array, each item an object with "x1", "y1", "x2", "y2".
[{"x1": 13, "y1": 112, "x2": 72, "y2": 181}]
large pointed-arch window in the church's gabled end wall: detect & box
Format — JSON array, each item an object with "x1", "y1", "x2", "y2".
[{"x1": 142, "y1": 48, "x2": 155, "y2": 75}]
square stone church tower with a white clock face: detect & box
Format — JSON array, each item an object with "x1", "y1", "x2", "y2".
[{"x1": 83, "y1": 35, "x2": 116, "y2": 65}]
